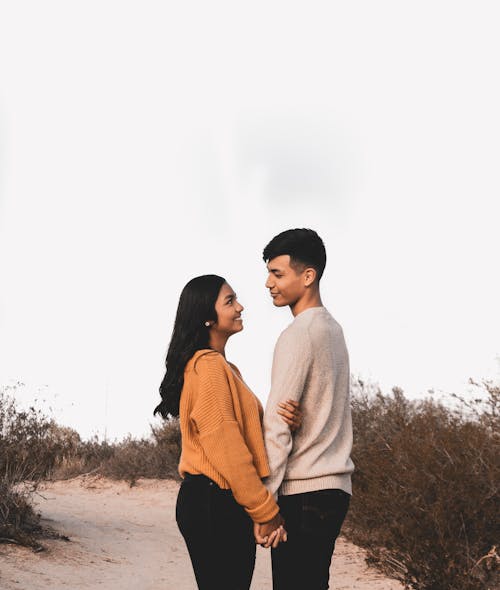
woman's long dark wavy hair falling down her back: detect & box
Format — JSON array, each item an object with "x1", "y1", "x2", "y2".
[{"x1": 153, "y1": 275, "x2": 226, "y2": 418}]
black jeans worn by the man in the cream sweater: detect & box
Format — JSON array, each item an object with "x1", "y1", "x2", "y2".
[{"x1": 272, "y1": 490, "x2": 351, "y2": 590}]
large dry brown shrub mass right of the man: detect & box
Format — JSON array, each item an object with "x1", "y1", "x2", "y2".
[{"x1": 345, "y1": 382, "x2": 499, "y2": 590}]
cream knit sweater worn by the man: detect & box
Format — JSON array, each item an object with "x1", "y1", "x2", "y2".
[{"x1": 264, "y1": 307, "x2": 354, "y2": 495}]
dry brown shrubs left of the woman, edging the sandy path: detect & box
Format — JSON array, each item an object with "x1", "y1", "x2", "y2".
[{"x1": 0, "y1": 384, "x2": 180, "y2": 547}]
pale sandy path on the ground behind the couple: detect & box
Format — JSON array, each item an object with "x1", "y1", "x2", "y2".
[{"x1": 0, "y1": 478, "x2": 402, "y2": 590}]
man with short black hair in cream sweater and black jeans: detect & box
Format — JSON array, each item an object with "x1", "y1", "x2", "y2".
[{"x1": 263, "y1": 229, "x2": 354, "y2": 590}]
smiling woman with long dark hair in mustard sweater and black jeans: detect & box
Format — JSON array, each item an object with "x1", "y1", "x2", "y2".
[{"x1": 155, "y1": 275, "x2": 300, "y2": 590}]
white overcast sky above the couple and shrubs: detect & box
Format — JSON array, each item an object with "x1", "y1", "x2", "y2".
[{"x1": 0, "y1": 0, "x2": 500, "y2": 437}]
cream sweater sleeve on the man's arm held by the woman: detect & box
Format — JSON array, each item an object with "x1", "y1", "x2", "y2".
[{"x1": 264, "y1": 329, "x2": 312, "y2": 496}]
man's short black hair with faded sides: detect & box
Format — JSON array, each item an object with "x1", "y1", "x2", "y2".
[{"x1": 262, "y1": 228, "x2": 326, "y2": 281}]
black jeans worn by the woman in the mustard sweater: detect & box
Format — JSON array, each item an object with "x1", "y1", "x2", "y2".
[{"x1": 176, "y1": 475, "x2": 255, "y2": 590}]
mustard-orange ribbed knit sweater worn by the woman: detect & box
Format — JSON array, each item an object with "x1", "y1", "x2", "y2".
[{"x1": 179, "y1": 349, "x2": 279, "y2": 522}]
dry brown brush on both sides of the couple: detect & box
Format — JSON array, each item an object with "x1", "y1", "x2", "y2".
[{"x1": 0, "y1": 382, "x2": 500, "y2": 590}]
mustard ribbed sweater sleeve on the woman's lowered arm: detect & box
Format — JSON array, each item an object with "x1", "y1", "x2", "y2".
[{"x1": 191, "y1": 353, "x2": 279, "y2": 522}]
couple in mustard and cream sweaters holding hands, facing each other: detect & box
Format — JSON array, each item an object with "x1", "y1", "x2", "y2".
[{"x1": 155, "y1": 229, "x2": 354, "y2": 590}]
